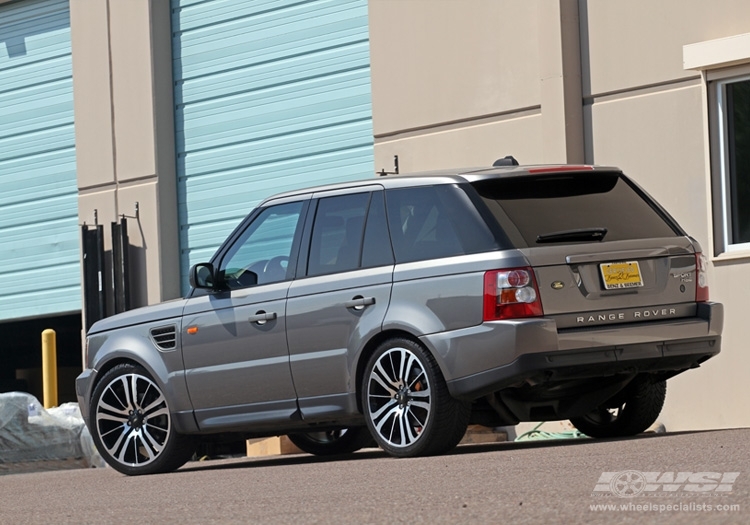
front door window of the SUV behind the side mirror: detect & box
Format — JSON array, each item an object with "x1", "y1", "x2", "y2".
[{"x1": 219, "y1": 202, "x2": 303, "y2": 289}]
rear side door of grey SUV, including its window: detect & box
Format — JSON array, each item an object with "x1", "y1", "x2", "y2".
[{"x1": 287, "y1": 186, "x2": 393, "y2": 420}]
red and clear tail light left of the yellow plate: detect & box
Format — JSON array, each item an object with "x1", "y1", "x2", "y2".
[{"x1": 484, "y1": 267, "x2": 544, "y2": 321}]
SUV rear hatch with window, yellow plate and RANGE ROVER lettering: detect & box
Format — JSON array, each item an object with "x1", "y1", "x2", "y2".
[{"x1": 472, "y1": 171, "x2": 707, "y2": 329}]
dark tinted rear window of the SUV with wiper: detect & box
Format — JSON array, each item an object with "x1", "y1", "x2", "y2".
[{"x1": 472, "y1": 172, "x2": 681, "y2": 248}]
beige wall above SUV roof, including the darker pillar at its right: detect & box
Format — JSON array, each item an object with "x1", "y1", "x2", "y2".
[{"x1": 368, "y1": 0, "x2": 584, "y2": 171}]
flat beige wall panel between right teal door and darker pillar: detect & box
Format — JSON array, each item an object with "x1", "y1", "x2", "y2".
[{"x1": 368, "y1": 0, "x2": 541, "y2": 171}]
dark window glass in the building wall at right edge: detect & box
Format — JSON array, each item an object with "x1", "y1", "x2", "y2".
[{"x1": 719, "y1": 79, "x2": 750, "y2": 244}]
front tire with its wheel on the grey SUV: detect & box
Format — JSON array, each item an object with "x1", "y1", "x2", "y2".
[{"x1": 90, "y1": 364, "x2": 196, "y2": 476}]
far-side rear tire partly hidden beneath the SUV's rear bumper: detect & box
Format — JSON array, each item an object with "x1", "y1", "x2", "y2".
[{"x1": 570, "y1": 376, "x2": 667, "y2": 438}]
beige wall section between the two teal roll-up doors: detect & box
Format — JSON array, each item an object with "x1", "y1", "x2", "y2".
[{"x1": 70, "y1": 0, "x2": 180, "y2": 306}]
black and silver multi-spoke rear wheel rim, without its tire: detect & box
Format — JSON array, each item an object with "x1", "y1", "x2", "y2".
[{"x1": 365, "y1": 347, "x2": 433, "y2": 448}]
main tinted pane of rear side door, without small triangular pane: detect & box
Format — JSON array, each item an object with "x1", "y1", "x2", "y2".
[{"x1": 307, "y1": 193, "x2": 370, "y2": 276}]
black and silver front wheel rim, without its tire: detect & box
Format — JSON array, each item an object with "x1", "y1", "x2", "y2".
[{"x1": 94, "y1": 373, "x2": 171, "y2": 467}]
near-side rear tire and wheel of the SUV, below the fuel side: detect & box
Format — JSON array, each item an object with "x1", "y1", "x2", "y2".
[{"x1": 361, "y1": 338, "x2": 471, "y2": 457}]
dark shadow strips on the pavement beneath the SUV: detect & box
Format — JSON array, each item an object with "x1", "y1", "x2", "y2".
[{"x1": 175, "y1": 430, "x2": 720, "y2": 474}]
